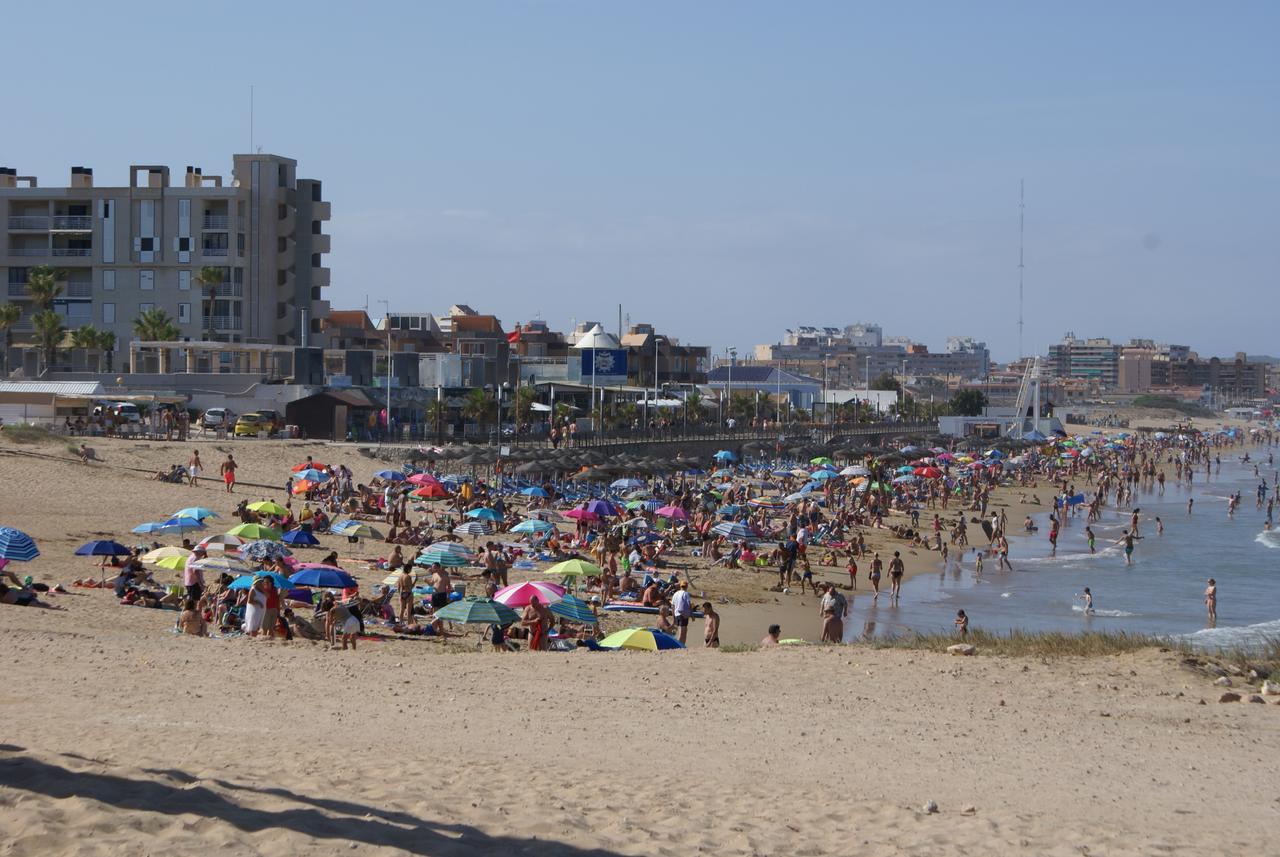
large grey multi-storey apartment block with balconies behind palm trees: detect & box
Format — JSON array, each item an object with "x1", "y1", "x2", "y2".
[{"x1": 0, "y1": 153, "x2": 330, "y2": 360}]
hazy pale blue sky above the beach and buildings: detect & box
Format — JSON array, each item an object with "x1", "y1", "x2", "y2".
[{"x1": 0, "y1": 0, "x2": 1280, "y2": 361}]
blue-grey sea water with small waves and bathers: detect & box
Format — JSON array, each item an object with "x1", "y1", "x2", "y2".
[{"x1": 846, "y1": 450, "x2": 1280, "y2": 649}]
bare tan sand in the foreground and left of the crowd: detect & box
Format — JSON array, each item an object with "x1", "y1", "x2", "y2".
[{"x1": 0, "y1": 443, "x2": 1280, "y2": 857}]
